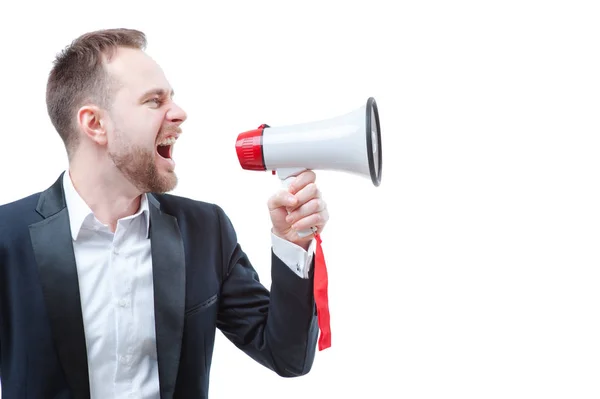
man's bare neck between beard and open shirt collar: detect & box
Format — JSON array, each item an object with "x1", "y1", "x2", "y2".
[{"x1": 69, "y1": 154, "x2": 142, "y2": 233}]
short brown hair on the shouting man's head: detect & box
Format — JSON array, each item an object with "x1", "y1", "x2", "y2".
[{"x1": 46, "y1": 29, "x2": 146, "y2": 157}]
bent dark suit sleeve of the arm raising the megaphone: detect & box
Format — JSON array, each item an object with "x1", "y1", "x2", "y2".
[{"x1": 217, "y1": 207, "x2": 318, "y2": 377}]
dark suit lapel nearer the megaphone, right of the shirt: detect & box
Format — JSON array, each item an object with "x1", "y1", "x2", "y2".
[{"x1": 148, "y1": 195, "x2": 185, "y2": 399}]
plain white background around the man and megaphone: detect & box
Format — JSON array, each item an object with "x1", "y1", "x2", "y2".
[{"x1": 0, "y1": 0, "x2": 600, "y2": 399}]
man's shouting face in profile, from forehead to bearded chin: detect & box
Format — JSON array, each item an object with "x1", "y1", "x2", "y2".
[{"x1": 105, "y1": 48, "x2": 187, "y2": 193}]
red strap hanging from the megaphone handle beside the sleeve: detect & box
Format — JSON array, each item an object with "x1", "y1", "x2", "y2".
[{"x1": 314, "y1": 234, "x2": 331, "y2": 351}]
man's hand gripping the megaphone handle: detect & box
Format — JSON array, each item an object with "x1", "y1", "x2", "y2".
[{"x1": 267, "y1": 170, "x2": 329, "y2": 250}]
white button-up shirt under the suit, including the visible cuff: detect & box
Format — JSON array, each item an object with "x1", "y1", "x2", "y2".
[{"x1": 63, "y1": 170, "x2": 314, "y2": 399}]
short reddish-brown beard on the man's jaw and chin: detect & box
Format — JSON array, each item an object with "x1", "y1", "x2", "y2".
[{"x1": 108, "y1": 131, "x2": 177, "y2": 193}]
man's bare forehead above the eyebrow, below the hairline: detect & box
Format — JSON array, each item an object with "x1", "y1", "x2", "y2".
[{"x1": 105, "y1": 48, "x2": 170, "y2": 95}]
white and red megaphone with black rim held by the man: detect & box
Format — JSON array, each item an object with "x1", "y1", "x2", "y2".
[{"x1": 235, "y1": 97, "x2": 382, "y2": 236}]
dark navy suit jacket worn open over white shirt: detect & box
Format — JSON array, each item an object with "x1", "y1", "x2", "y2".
[{"x1": 0, "y1": 176, "x2": 318, "y2": 399}]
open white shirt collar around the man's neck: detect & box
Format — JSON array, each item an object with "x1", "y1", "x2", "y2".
[{"x1": 63, "y1": 169, "x2": 150, "y2": 240}]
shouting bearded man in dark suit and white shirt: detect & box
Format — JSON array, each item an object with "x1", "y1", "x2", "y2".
[{"x1": 0, "y1": 29, "x2": 328, "y2": 399}]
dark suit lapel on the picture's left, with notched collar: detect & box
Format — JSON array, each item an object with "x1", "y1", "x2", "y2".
[{"x1": 29, "y1": 175, "x2": 90, "y2": 399}]
